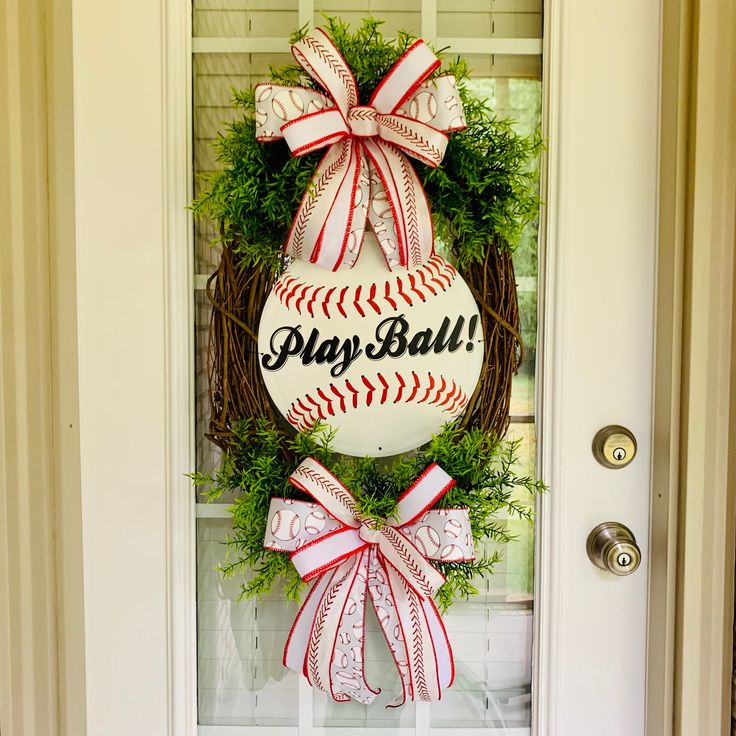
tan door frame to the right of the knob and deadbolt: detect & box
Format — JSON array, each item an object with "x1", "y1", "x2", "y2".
[{"x1": 647, "y1": 0, "x2": 736, "y2": 736}]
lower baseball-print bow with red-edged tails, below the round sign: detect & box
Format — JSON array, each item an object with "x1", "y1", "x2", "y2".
[{"x1": 264, "y1": 458, "x2": 474, "y2": 706}]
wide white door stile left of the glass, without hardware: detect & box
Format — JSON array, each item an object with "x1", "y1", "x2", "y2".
[{"x1": 73, "y1": 0, "x2": 195, "y2": 736}]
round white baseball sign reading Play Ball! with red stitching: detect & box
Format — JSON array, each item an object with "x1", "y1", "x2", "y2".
[{"x1": 258, "y1": 233, "x2": 484, "y2": 457}]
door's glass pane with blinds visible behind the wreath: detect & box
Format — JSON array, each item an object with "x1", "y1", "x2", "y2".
[{"x1": 193, "y1": 0, "x2": 542, "y2": 736}]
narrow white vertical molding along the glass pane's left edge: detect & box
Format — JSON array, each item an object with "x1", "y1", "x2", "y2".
[{"x1": 162, "y1": 0, "x2": 197, "y2": 736}]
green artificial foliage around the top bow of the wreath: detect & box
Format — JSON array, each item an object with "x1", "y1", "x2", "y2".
[{"x1": 193, "y1": 17, "x2": 541, "y2": 271}]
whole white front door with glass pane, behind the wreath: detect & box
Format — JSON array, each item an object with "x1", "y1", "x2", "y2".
[{"x1": 66, "y1": 0, "x2": 660, "y2": 736}]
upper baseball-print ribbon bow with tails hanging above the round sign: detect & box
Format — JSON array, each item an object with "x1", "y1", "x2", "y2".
[{"x1": 255, "y1": 29, "x2": 465, "y2": 271}]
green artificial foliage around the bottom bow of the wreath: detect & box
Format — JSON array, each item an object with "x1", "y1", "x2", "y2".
[{"x1": 193, "y1": 418, "x2": 544, "y2": 610}]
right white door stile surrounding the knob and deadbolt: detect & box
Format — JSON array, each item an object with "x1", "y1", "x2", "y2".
[{"x1": 535, "y1": 0, "x2": 660, "y2": 736}]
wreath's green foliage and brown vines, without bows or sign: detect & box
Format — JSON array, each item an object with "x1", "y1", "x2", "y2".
[{"x1": 193, "y1": 18, "x2": 544, "y2": 702}]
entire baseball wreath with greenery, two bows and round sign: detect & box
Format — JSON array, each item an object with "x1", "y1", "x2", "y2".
[{"x1": 193, "y1": 18, "x2": 543, "y2": 704}]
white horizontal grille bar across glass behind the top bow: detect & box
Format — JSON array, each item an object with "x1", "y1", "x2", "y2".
[{"x1": 192, "y1": 36, "x2": 542, "y2": 56}]
